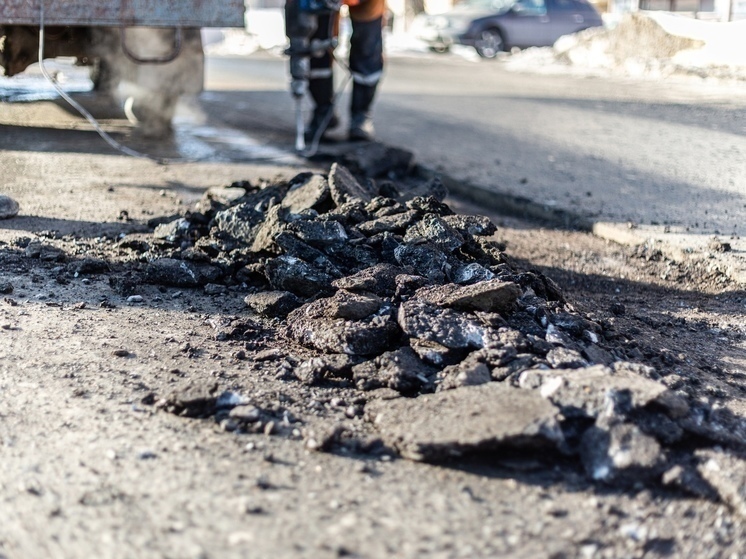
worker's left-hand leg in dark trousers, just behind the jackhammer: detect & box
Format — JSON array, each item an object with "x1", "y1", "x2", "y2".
[{"x1": 306, "y1": 15, "x2": 339, "y2": 142}]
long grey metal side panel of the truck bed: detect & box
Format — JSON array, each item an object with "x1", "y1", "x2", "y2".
[{"x1": 0, "y1": 0, "x2": 245, "y2": 27}]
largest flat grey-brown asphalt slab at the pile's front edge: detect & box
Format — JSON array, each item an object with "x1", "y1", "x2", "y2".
[{"x1": 366, "y1": 383, "x2": 563, "y2": 462}]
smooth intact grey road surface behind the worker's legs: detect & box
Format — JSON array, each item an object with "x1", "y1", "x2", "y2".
[{"x1": 201, "y1": 50, "x2": 746, "y2": 238}]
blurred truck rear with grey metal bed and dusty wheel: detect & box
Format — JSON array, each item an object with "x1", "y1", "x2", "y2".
[{"x1": 0, "y1": 0, "x2": 245, "y2": 137}]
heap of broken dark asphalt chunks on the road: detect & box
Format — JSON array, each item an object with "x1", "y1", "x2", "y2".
[{"x1": 8, "y1": 156, "x2": 746, "y2": 512}]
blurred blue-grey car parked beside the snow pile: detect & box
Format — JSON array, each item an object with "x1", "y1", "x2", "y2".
[{"x1": 413, "y1": 0, "x2": 603, "y2": 58}]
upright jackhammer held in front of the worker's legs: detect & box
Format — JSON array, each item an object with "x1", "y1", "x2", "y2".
[{"x1": 285, "y1": 0, "x2": 341, "y2": 152}]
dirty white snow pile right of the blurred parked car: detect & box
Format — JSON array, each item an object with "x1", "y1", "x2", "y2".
[{"x1": 505, "y1": 12, "x2": 746, "y2": 80}]
